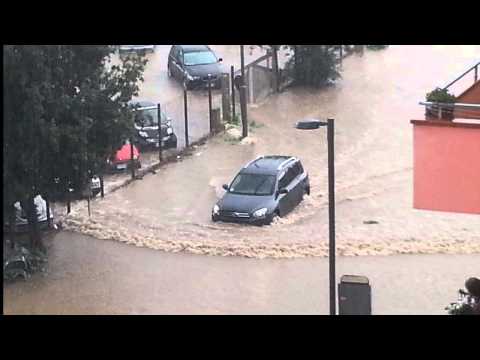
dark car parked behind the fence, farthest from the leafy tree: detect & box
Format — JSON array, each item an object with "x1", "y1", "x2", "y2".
[{"x1": 168, "y1": 45, "x2": 223, "y2": 89}]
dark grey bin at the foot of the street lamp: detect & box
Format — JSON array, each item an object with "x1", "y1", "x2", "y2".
[{"x1": 338, "y1": 275, "x2": 372, "y2": 315}]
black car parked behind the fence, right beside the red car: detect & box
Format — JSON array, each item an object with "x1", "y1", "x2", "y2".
[{"x1": 131, "y1": 101, "x2": 177, "y2": 149}]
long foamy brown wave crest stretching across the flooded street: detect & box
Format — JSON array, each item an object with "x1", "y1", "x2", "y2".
[{"x1": 65, "y1": 208, "x2": 480, "y2": 259}]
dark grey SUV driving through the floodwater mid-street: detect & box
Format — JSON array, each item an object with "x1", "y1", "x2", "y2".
[{"x1": 212, "y1": 156, "x2": 310, "y2": 225}]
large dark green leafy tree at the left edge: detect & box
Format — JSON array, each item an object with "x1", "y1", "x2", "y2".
[{"x1": 3, "y1": 45, "x2": 146, "y2": 246}]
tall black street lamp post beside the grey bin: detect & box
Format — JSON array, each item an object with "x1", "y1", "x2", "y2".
[{"x1": 295, "y1": 119, "x2": 336, "y2": 315}]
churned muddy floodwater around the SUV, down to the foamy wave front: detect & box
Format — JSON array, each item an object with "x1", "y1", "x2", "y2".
[{"x1": 66, "y1": 46, "x2": 480, "y2": 258}]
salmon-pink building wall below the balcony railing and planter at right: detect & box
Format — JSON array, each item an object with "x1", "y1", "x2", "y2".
[{"x1": 412, "y1": 120, "x2": 480, "y2": 215}]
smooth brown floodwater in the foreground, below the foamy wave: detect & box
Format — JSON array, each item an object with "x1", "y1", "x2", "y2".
[{"x1": 4, "y1": 232, "x2": 480, "y2": 315}]
